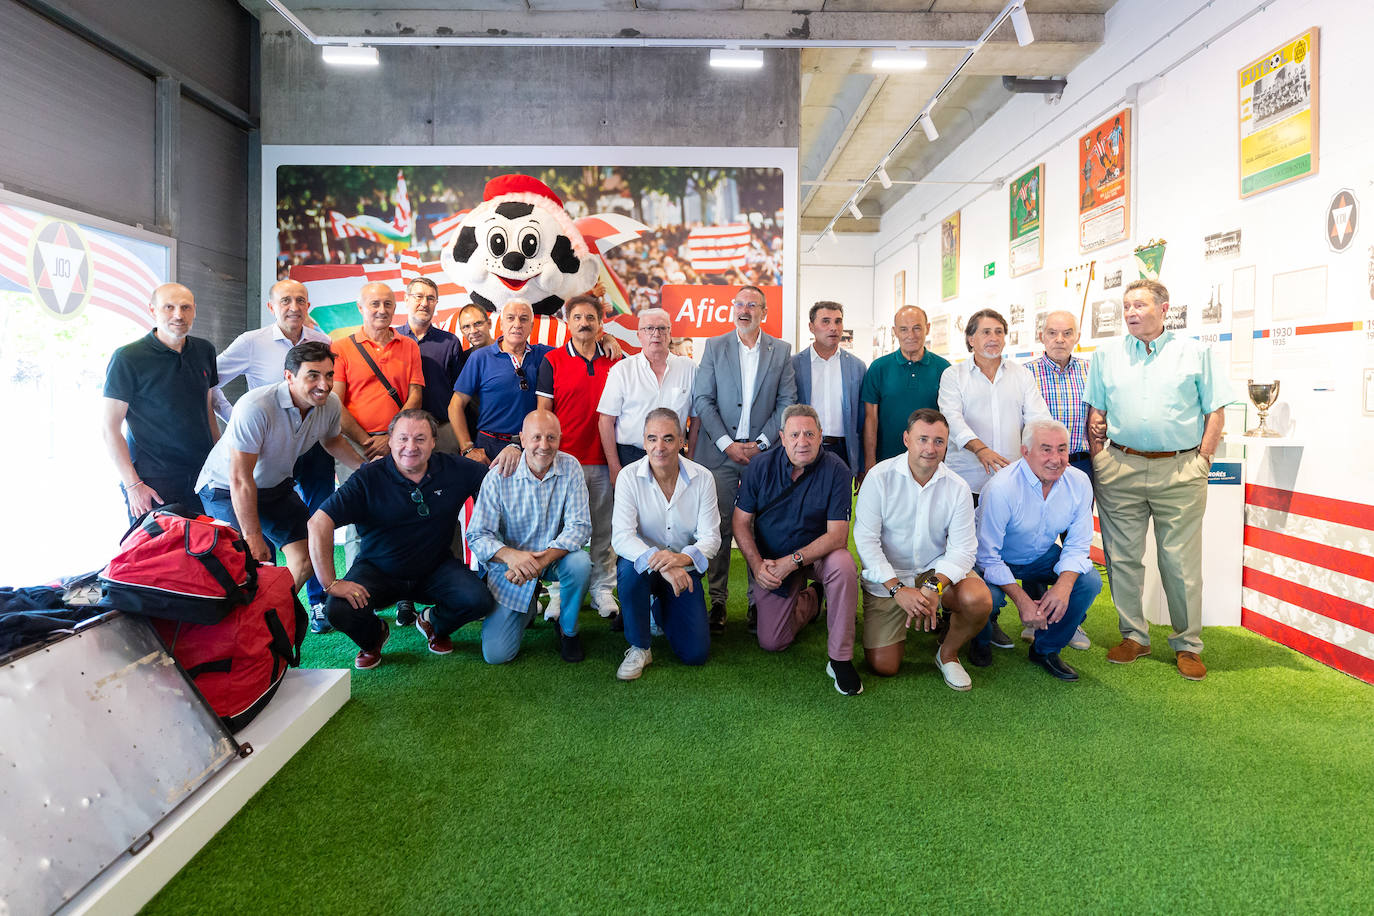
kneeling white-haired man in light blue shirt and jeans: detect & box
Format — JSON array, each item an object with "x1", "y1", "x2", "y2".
[{"x1": 969, "y1": 419, "x2": 1102, "y2": 681}]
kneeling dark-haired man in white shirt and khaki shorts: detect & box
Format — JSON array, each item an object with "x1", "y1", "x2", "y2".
[{"x1": 855, "y1": 408, "x2": 992, "y2": 691}]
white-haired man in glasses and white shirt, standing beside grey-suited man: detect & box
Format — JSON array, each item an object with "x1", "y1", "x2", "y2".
[{"x1": 596, "y1": 309, "x2": 699, "y2": 486}]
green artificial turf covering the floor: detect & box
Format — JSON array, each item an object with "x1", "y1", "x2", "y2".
[{"x1": 144, "y1": 556, "x2": 1374, "y2": 916}]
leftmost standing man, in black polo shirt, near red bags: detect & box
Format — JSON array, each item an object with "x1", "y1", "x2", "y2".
[{"x1": 102, "y1": 283, "x2": 220, "y2": 522}]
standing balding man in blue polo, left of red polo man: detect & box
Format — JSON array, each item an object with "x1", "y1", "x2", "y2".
[{"x1": 448, "y1": 299, "x2": 554, "y2": 475}]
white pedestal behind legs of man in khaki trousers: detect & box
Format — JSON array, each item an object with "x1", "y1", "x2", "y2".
[{"x1": 1142, "y1": 460, "x2": 1245, "y2": 626}]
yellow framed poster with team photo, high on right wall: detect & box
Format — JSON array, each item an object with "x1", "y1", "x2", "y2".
[{"x1": 1238, "y1": 29, "x2": 1319, "y2": 199}]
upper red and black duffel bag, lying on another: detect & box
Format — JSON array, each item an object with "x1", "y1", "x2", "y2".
[{"x1": 100, "y1": 508, "x2": 257, "y2": 623}]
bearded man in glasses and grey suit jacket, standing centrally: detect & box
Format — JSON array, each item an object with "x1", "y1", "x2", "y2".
[{"x1": 692, "y1": 286, "x2": 797, "y2": 633}]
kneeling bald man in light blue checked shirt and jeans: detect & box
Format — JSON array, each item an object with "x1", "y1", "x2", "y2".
[{"x1": 467, "y1": 411, "x2": 592, "y2": 665}]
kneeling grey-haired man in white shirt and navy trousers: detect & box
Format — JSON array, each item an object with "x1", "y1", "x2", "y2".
[{"x1": 611, "y1": 407, "x2": 720, "y2": 681}]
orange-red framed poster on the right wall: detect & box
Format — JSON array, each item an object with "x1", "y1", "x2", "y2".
[{"x1": 1079, "y1": 108, "x2": 1131, "y2": 254}]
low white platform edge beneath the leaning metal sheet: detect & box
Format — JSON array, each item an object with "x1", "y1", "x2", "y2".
[{"x1": 59, "y1": 669, "x2": 349, "y2": 916}]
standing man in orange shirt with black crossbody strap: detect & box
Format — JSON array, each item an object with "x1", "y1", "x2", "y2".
[{"x1": 334, "y1": 283, "x2": 425, "y2": 566}]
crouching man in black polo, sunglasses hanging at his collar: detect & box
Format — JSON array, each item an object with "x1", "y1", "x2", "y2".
[{"x1": 309, "y1": 409, "x2": 492, "y2": 669}]
